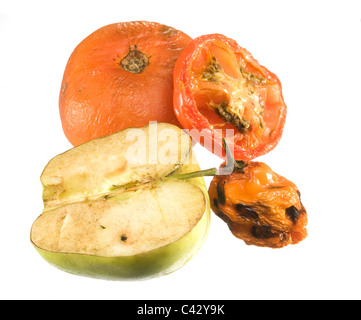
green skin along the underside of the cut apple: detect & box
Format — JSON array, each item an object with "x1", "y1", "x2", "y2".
[{"x1": 33, "y1": 178, "x2": 211, "y2": 281}]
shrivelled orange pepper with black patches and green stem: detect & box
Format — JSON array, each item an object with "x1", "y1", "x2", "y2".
[{"x1": 170, "y1": 140, "x2": 307, "y2": 248}]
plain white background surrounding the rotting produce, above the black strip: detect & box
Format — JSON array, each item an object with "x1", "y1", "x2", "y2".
[{"x1": 0, "y1": 0, "x2": 361, "y2": 299}]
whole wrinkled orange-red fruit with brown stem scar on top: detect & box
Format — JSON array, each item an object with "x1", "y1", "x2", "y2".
[{"x1": 59, "y1": 21, "x2": 192, "y2": 146}]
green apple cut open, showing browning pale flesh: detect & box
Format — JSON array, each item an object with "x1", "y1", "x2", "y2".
[{"x1": 31, "y1": 123, "x2": 210, "y2": 280}]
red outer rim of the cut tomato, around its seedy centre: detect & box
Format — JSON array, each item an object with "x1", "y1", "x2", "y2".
[{"x1": 173, "y1": 34, "x2": 287, "y2": 160}]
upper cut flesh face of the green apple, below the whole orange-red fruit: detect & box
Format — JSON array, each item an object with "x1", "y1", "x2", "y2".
[{"x1": 41, "y1": 123, "x2": 191, "y2": 209}]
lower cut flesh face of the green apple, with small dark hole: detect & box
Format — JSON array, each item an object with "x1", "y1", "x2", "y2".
[{"x1": 31, "y1": 179, "x2": 206, "y2": 257}]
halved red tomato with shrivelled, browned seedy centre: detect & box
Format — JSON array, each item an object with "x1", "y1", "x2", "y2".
[{"x1": 173, "y1": 34, "x2": 287, "y2": 160}]
